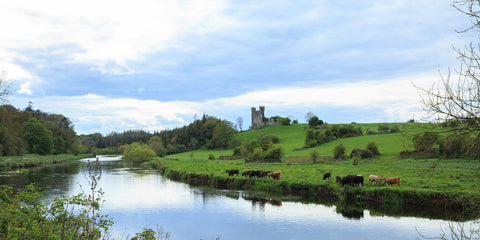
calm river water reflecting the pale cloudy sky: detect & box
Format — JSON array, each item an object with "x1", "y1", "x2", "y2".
[{"x1": 0, "y1": 157, "x2": 472, "y2": 240}]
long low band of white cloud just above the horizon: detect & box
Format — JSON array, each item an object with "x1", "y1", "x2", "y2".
[{"x1": 18, "y1": 77, "x2": 433, "y2": 133}]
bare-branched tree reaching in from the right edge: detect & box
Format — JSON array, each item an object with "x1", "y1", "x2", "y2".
[{"x1": 416, "y1": 0, "x2": 480, "y2": 149}]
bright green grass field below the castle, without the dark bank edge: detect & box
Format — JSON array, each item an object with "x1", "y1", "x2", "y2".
[{"x1": 154, "y1": 123, "x2": 480, "y2": 207}]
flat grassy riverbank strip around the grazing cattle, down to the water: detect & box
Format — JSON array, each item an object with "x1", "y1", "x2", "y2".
[{"x1": 150, "y1": 159, "x2": 480, "y2": 219}]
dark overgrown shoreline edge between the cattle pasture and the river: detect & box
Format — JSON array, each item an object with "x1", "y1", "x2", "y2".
[{"x1": 152, "y1": 164, "x2": 480, "y2": 221}]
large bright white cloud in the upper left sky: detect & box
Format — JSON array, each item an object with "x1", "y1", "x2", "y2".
[{"x1": 0, "y1": 0, "x2": 232, "y2": 74}]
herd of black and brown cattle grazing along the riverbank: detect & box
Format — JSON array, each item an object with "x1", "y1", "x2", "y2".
[{"x1": 225, "y1": 169, "x2": 400, "y2": 187}]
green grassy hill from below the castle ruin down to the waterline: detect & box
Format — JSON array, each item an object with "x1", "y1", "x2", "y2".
[{"x1": 152, "y1": 123, "x2": 480, "y2": 218}]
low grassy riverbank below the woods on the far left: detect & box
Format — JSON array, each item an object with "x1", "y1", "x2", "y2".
[{"x1": 0, "y1": 154, "x2": 93, "y2": 171}]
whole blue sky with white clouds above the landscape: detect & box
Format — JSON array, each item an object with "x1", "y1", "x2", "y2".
[{"x1": 0, "y1": 0, "x2": 478, "y2": 135}]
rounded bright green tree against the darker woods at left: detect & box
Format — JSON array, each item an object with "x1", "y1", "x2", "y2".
[{"x1": 23, "y1": 118, "x2": 53, "y2": 155}]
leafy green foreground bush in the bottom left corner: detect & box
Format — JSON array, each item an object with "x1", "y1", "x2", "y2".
[{"x1": 0, "y1": 158, "x2": 113, "y2": 239}]
